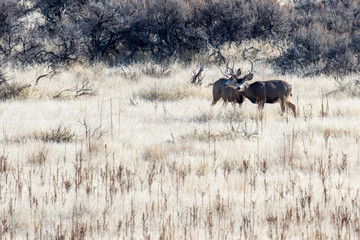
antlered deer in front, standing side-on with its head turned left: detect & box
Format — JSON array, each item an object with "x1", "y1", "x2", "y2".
[{"x1": 225, "y1": 62, "x2": 296, "y2": 117}]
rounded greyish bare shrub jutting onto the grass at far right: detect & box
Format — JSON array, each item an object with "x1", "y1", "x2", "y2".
[{"x1": 275, "y1": 29, "x2": 359, "y2": 76}]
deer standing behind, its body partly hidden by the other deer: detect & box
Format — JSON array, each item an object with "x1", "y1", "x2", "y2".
[{"x1": 211, "y1": 62, "x2": 249, "y2": 106}]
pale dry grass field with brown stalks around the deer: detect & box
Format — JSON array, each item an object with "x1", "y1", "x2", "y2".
[{"x1": 0, "y1": 62, "x2": 360, "y2": 239}]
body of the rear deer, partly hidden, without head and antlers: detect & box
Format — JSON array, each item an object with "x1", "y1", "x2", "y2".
[{"x1": 211, "y1": 78, "x2": 244, "y2": 105}]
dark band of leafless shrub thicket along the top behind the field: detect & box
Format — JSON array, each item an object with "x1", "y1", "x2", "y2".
[{"x1": 0, "y1": 0, "x2": 360, "y2": 74}]
